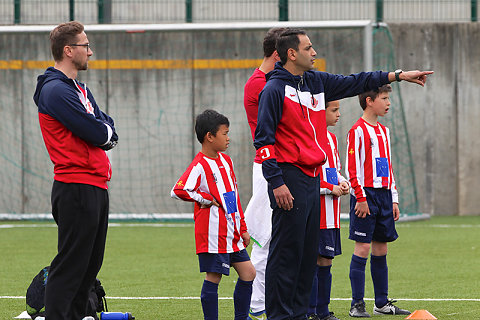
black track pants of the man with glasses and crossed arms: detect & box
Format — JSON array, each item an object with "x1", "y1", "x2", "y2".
[{"x1": 45, "y1": 181, "x2": 109, "y2": 320}]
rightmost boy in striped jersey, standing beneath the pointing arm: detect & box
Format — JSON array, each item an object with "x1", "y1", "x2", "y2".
[{"x1": 346, "y1": 84, "x2": 410, "y2": 318}]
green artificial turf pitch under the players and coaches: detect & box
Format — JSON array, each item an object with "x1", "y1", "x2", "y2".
[{"x1": 0, "y1": 217, "x2": 480, "y2": 320}]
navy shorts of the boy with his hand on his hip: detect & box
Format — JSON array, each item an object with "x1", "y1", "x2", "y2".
[{"x1": 198, "y1": 249, "x2": 250, "y2": 276}]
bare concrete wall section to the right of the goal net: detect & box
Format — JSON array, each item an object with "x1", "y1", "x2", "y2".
[{"x1": 390, "y1": 23, "x2": 480, "y2": 215}]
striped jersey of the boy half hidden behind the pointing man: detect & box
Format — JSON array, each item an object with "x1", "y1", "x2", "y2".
[{"x1": 320, "y1": 131, "x2": 347, "y2": 229}]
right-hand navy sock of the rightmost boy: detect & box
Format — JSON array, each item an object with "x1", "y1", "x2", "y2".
[{"x1": 370, "y1": 254, "x2": 388, "y2": 308}]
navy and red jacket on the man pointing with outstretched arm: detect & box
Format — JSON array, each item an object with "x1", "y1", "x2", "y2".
[{"x1": 254, "y1": 62, "x2": 389, "y2": 189}]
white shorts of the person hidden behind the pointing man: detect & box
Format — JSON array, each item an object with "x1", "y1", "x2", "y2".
[{"x1": 245, "y1": 163, "x2": 272, "y2": 247}]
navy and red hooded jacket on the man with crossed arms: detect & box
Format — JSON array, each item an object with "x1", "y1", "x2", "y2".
[{"x1": 33, "y1": 67, "x2": 118, "y2": 189}]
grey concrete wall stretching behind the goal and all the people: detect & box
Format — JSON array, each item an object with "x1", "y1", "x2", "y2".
[{"x1": 0, "y1": 24, "x2": 480, "y2": 215}]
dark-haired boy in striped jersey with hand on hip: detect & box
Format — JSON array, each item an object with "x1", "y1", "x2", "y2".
[{"x1": 171, "y1": 110, "x2": 255, "y2": 320}]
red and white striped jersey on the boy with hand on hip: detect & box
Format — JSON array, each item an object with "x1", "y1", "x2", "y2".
[{"x1": 171, "y1": 152, "x2": 247, "y2": 254}]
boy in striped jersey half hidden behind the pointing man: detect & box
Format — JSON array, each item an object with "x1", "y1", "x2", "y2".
[{"x1": 308, "y1": 100, "x2": 350, "y2": 320}]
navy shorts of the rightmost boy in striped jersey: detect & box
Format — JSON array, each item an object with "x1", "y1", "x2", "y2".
[{"x1": 348, "y1": 188, "x2": 398, "y2": 243}]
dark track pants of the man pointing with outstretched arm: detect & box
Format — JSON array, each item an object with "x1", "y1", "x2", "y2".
[{"x1": 265, "y1": 164, "x2": 320, "y2": 320}]
